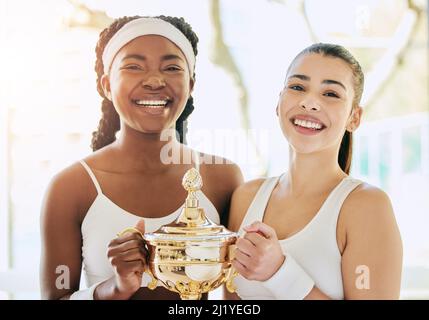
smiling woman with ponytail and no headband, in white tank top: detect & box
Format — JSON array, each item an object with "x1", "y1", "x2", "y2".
[{"x1": 227, "y1": 43, "x2": 402, "y2": 299}]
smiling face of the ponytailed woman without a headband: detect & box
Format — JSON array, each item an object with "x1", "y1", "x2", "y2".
[{"x1": 277, "y1": 53, "x2": 361, "y2": 153}]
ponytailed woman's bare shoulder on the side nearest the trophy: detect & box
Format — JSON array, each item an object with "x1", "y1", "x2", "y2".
[{"x1": 228, "y1": 178, "x2": 266, "y2": 231}]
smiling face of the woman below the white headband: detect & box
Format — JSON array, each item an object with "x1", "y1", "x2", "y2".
[{"x1": 101, "y1": 35, "x2": 193, "y2": 133}]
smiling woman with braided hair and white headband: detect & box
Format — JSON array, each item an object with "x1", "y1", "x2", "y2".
[{"x1": 41, "y1": 16, "x2": 243, "y2": 299}]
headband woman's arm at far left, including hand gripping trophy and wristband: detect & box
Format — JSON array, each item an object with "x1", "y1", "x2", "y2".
[{"x1": 40, "y1": 165, "x2": 146, "y2": 300}]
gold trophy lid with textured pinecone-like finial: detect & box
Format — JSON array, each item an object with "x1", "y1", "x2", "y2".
[{"x1": 144, "y1": 168, "x2": 238, "y2": 243}]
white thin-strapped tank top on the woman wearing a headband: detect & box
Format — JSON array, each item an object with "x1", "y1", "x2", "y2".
[{"x1": 80, "y1": 160, "x2": 220, "y2": 287}]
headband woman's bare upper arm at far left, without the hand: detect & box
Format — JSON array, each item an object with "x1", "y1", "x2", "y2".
[{"x1": 40, "y1": 170, "x2": 86, "y2": 299}]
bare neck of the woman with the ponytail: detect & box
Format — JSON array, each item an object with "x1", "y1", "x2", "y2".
[{"x1": 286, "y1": 150, "x2": 347, "y2": 196}]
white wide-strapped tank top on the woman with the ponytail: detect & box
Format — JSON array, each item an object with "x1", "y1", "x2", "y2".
[{"x1": 234, "y1": 176, "x2": 362, "y2": 300}]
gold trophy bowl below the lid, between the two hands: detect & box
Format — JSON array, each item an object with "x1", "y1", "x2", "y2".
[{"x1": 144, "y1": 222, "x2": 237, "y2": 300}]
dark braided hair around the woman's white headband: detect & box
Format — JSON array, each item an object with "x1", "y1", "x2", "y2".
[{"x1": 91, "y1": 15, "x2": 198, "y2": 151}]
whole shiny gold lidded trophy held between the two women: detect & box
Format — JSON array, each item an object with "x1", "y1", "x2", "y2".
[{"x1": 118, "y1": 168, "x2": 238, "y2": 300}]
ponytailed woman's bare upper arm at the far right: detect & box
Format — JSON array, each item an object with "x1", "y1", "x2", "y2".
[{"x1": 334, "y1": 184, "x2": 402, "y2": 299}]
